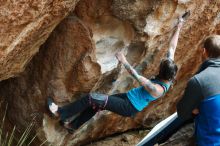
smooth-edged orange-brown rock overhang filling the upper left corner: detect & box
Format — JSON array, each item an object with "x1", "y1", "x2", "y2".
[{"x1": 0, "y1": 0, "x2": 77, "y2": 80}]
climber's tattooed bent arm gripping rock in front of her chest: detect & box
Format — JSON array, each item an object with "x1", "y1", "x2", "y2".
[{"x1": 116, "y1": 52, "x2": 163, "y2": 97}]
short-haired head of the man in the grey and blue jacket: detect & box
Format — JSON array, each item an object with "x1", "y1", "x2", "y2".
[{"x1": 204, "y1": 35, "x2": 220, "y2": 58}]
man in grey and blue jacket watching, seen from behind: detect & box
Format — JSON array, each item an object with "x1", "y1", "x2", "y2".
[{"x1": 144, "y1": 35, "x2": 220, "y2": 146}]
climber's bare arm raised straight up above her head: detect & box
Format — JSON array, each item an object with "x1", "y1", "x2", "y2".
[{"x1": 167, "y1": 21, "x2": 183, "y2": 60}]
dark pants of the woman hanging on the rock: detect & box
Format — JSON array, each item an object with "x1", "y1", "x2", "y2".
[{"x1": 58, "y1": 93, "x2": 138, "y2": 128}]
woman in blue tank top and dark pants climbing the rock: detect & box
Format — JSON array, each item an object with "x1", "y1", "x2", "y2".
[{"x1": 48, "y1": 14, "x2": 184, "y2": 132}]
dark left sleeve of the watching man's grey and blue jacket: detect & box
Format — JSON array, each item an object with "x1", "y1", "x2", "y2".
[{"x1": 177, "y1": 77, "x2": 203, "y2": 120}]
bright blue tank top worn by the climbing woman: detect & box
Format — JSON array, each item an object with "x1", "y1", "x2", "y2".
[{"x1": 127, "y1": 79, "x2": 170, "y2": 111}]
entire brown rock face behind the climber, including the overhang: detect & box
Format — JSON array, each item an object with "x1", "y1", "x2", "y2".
[{"x1": 0, "y1": 0, "x2": 220, "y2": 146}]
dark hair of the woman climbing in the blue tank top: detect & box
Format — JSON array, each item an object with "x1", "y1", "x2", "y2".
[{"x1": 157, "y1": 58, "x2": 178, "y2": 81}]
